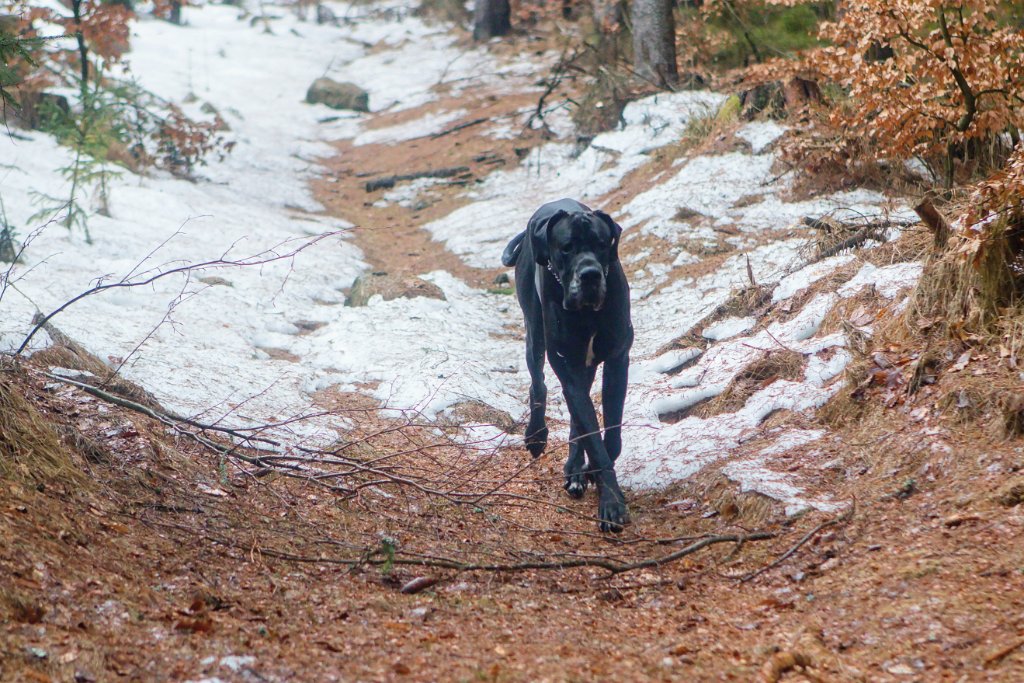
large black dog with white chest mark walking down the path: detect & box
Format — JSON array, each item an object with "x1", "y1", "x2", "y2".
[{"x1": 502, "y1": 200, "x2": 633, "y2": 531}]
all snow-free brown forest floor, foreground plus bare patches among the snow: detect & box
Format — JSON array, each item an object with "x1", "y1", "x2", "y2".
[{"x1": 6, "y1": 2, "x2": 1024, "y2": 683}]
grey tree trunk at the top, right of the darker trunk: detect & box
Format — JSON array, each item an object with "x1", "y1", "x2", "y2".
[{"x1": 631, "y1": 0, "x2": 679, "y2": 88}]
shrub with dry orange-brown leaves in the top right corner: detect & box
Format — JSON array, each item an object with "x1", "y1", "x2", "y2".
[{"x1": 776, "y1": 0, "x2": 1024, "y2": 187}]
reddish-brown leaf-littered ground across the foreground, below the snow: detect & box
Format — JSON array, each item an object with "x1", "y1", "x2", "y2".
[{"x1": 6, "y1": 352, "x2": 1024, "y2": 681}]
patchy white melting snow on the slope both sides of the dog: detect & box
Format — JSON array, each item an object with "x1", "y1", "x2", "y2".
[{"x1": 0, "y1": 3, "x2": 920, "y2": 509}]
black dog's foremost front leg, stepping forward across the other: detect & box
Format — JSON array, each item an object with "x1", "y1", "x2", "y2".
[{"x1": 549, "y1": 366, "x2": 629, "y2": 531}]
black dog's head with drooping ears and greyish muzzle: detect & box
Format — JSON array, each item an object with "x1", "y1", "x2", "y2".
[{"x1": 530, "y1": 211, "x2": 623, "y2": 310}]
